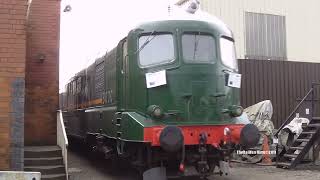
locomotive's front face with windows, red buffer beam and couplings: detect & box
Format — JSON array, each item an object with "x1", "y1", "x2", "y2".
[{"x1": 122, "y1": 20, "x2": 259, "y2": 176}]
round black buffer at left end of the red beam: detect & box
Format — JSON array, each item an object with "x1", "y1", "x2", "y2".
[{"x1": 159, "y1": 126, "x2": 184, "y2": 152}]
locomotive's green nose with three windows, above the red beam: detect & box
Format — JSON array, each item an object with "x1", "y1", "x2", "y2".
[{"x1": 128, "y1": 20, "x2": 239, "y2": 123}]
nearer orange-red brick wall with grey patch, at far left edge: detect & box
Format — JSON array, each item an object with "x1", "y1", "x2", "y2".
[{"x1": 0, "y1": 0, "x2": 27, "y2": 170}]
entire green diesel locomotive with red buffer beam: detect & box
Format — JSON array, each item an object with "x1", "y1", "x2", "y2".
[{"x1": 63, "y1": 5, "x2": 259, "y2": 179}]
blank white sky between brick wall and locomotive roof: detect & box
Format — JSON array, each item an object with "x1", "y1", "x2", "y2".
[{"x1": 60, "y1": 0, "x2": 176, "y2": 91}]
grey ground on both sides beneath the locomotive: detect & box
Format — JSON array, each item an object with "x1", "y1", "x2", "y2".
[{"x1": 68, "y1": 151, "x2": 320, "y2": 180}]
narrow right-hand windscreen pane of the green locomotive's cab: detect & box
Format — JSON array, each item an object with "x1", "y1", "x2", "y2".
[{"x1": 220, "y1": 37, "x2": 238, "y2": 69}]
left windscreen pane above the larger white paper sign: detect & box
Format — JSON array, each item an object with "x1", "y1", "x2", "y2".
[{"x1": 139, "y1": 34, "x2": 174, "y2": 67}]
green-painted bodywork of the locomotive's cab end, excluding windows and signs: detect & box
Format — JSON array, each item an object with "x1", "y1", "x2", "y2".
[{"x1": 110, "y1": 20, "x2": 239, "y2": 141}]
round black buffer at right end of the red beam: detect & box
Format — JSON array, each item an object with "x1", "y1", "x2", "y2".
[{"x1": 240, "y1": 124, "x2": 260, "y2": 148}]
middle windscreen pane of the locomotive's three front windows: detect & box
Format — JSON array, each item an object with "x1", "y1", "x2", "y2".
[{"x1": 182, "y1": 34, "x2": 217, "y2": 63}]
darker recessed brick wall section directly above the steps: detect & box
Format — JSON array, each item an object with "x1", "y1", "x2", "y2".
[{"x1": 25, "y1": 0, "x2": 60, "y2": 145}]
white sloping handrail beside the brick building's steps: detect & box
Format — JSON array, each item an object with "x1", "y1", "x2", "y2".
[{"x1": 57, "y1": 110, "x2": 69, "y2": 180}]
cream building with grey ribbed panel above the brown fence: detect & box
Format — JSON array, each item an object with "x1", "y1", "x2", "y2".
[{"x1": 176, "y1": 0, "x2": 320, "y2": 62}]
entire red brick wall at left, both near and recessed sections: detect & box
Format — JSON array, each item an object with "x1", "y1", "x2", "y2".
[{"x1": 0, "y1": 0, "x2": 60, "y2": 170}]
